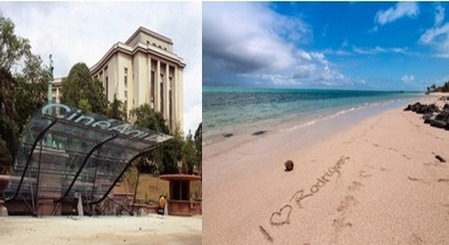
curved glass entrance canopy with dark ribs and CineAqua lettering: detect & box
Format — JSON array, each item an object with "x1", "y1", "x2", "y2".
[{"x1": 3, "y1": 104, "x2": 171, "y2": 212}]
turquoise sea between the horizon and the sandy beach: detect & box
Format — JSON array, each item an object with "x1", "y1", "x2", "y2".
[{"x1": 203, "y1": 87, "x2": 424, "y2": 144}]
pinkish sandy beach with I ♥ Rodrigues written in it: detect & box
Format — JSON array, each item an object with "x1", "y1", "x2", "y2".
[{"x1": 203, "y1": 94, "x2": 449, "y2": 245}]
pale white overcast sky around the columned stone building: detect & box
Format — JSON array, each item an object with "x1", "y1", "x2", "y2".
[{"x1": 0, "y1": 2, "x2": 202, "y2": 134}]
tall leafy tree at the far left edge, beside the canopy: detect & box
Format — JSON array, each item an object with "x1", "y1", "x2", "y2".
[{"x1": 0, "y1": 13, "x2": 50, "y2": 173}]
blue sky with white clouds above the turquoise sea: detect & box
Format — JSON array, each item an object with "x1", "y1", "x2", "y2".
[{"x1": 202, "y1": 2, "x2": 449, "y2": 90}]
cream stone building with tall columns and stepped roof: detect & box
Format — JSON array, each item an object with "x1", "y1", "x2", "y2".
[{"x1": 90, "y1": 27, "x2": 186, "y2": 129}]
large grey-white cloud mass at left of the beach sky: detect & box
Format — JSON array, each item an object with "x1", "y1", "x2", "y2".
[{"x1": 203, "y1": 3, "x2": 344, "y2": 86}]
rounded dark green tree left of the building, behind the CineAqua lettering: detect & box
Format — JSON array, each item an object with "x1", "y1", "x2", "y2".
[{"x1": 61, "y1": 63, "x2": 108, "y2": 114}]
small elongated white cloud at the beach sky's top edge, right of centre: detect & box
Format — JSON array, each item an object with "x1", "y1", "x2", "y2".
[{"x1": 375, "y1": 2, "x2": 419, "y2": 25}]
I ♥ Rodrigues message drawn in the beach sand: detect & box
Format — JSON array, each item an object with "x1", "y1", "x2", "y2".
[{"x1": 259, "y1": 156, "x2": 349, "y2": 242}]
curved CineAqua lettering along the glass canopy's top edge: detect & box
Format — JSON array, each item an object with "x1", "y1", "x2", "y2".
[{"x1": 42, "y1": 103, "x2": 171, "y2": 142}]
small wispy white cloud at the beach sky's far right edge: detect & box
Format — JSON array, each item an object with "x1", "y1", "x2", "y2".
[{"x1": 419, "y1": 5, "x2": 449, "y2": 58}]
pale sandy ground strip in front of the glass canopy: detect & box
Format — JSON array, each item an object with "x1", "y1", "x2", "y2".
[{"x1": 0, "y1": 214, "x2": 202, "y2": 245}]
